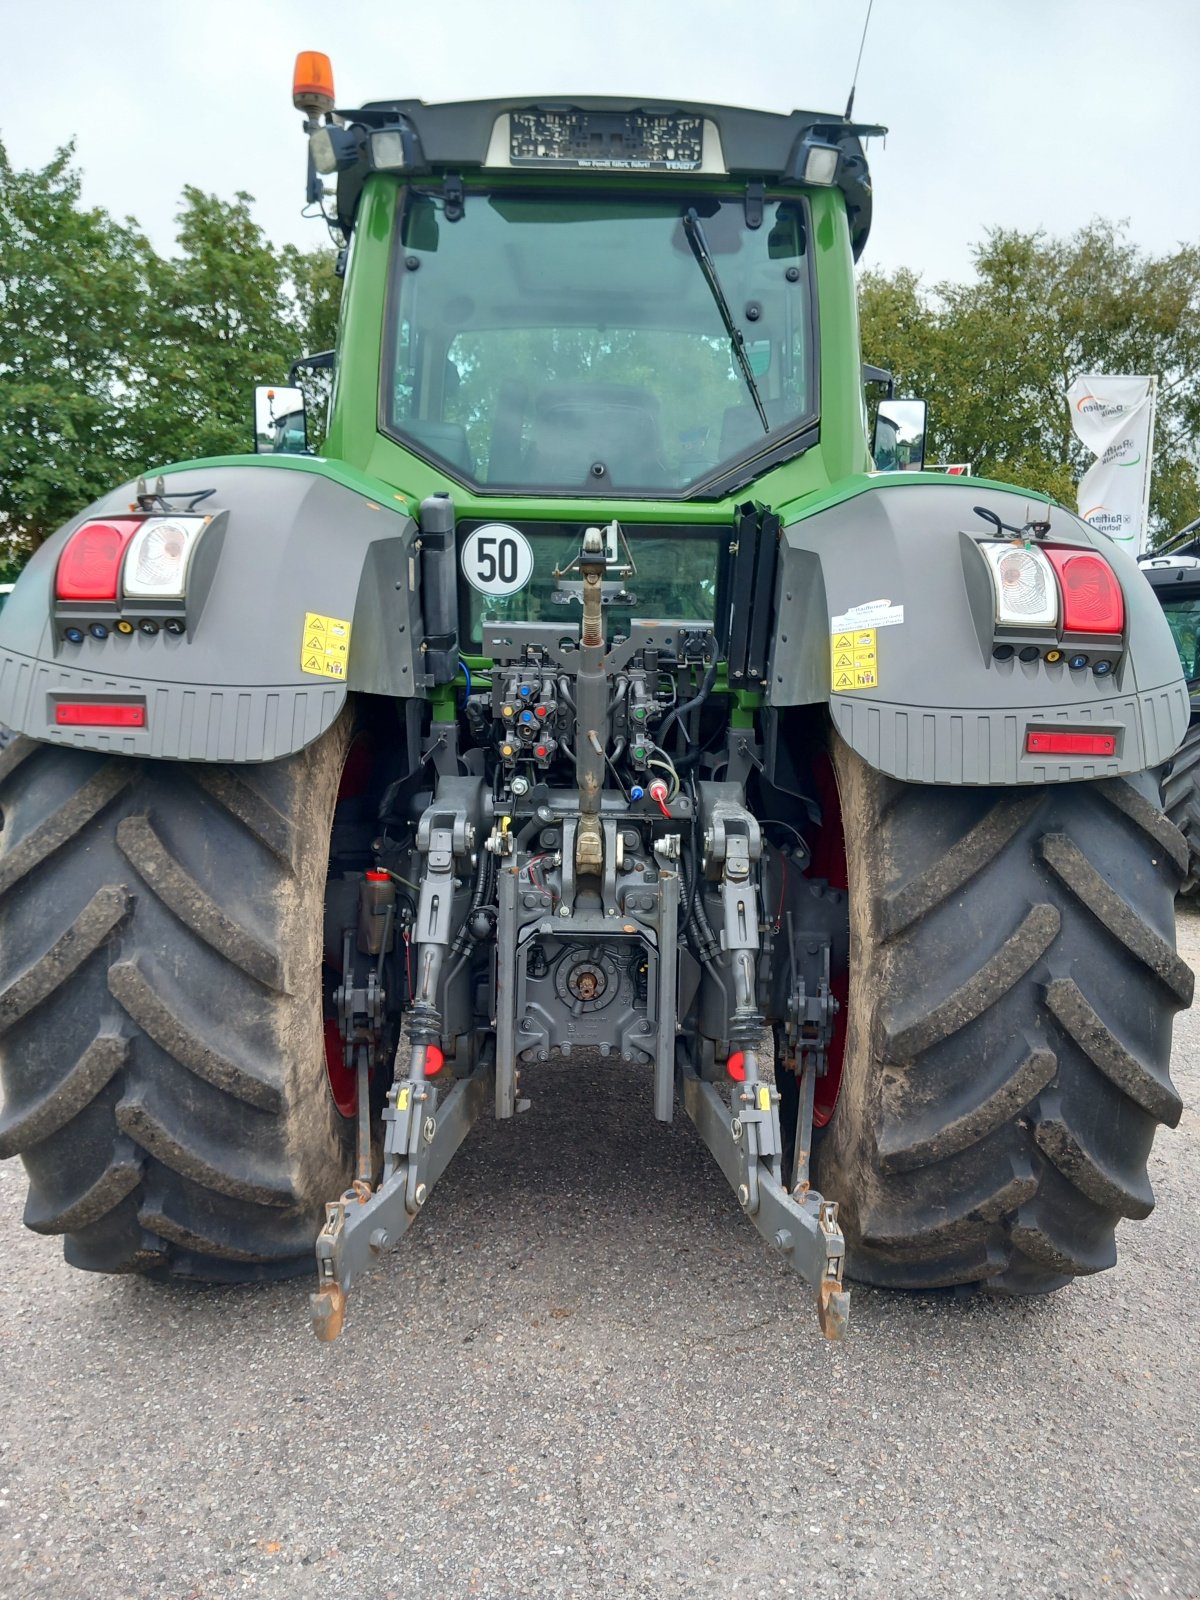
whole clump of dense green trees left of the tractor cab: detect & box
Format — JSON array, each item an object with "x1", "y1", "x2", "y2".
[{"x1": 0, "y1": 144, "x2": 341, "y2": 562}]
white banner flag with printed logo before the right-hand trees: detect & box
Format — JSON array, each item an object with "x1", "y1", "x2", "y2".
[{"x1": 1067, "y1": 373, "x2": 1158, "y2": 555}]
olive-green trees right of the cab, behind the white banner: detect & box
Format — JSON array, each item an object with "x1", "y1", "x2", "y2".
[{"x1": 859, "y1": 221, "x2": 1200, "y2": 533}]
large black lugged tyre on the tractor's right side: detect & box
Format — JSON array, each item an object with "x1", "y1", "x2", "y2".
[{"x1": 814, "y1": 741, "x2": 1192, "y2": 1294}]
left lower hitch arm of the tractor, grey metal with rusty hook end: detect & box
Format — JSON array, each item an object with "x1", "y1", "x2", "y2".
[{"x1": 310, "y1": 1064, "x2": 493, "y2": 1344}]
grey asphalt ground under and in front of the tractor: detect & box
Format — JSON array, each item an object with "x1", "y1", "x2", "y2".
[{"x1": 0, "y1": 912, "x2": 1200, "y2": 1600}]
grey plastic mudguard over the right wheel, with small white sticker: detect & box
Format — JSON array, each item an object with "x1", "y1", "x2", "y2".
[{"x1": 770, "y1": 477, "x2": 1189, "y2": 784}]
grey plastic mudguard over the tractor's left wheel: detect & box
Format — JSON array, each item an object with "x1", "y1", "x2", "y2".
[{"x1": 0, "y1": 464, "x2": 424, "y2": 762}]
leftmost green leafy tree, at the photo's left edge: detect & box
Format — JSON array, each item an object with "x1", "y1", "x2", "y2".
[{"x1": 0, "y1": 144, "x2": 154, "y2": 558}]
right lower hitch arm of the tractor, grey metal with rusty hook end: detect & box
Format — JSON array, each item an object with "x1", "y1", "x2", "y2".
[{"x1": 682, "y1": 1066, "x2": 850, "y2": 1339}]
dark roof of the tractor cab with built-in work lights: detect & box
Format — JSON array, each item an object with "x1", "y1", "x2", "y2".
[{"x1": 329, "y1": 94, "x2": 886, "y2": 256}]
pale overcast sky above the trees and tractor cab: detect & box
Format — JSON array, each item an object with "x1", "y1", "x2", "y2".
[{"x1": 0, "y1": 0, "x2": 1200, "y2": 282}]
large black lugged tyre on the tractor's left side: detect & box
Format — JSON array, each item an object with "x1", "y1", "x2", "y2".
[{"x1": 0, "y1": 715, "x2": 360, "y2": 1282}]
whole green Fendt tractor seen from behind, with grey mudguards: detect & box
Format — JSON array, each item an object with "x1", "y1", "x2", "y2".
[{"x1": 0, "y1": 56, "x2": 1192, "y2": 1339}]
